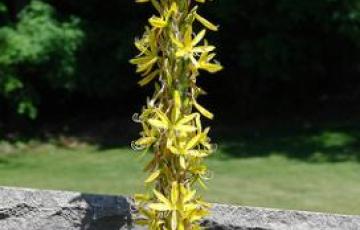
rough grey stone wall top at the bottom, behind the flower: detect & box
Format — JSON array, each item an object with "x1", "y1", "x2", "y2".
[{"x1": 0, "y1": 187, "x2": 360, "y2": 230}]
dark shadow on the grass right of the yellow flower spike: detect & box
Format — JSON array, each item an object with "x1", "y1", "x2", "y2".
[{"x1": 219, "y1": 127, "x2": 360, "y2": 162}]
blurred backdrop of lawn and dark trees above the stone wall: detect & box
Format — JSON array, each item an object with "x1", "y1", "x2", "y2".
[{"x1": 0, "y1": 0, "x2": 360, "y2": 214}]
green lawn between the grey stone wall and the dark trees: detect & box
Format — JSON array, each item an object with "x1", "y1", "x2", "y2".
[{"x1": 0, "y1": 131, "x2": 360, "y2": 214}]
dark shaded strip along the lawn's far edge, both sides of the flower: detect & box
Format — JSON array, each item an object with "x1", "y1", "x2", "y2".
[{"x1": 0, "y1": 119, "x2": 360, "y2": 165}]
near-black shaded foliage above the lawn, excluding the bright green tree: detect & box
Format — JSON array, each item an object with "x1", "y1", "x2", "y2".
[{"x1": 0, "y1": 0, "x2": 360, "y2": 126}]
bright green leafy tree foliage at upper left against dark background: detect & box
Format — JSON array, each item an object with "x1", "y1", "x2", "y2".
[{"x1": 0, "y1": 0, "x2": 83, "y2": 118}]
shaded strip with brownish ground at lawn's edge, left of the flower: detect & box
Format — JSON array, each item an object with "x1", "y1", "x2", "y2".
[{"x1": 0, "y1": 119, "x2": 140, "y2": 152}]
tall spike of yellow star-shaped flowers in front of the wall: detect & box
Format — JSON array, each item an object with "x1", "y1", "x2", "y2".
[{"x1": 130, "y1": 0, "x2": 222, "y2": 230}]
